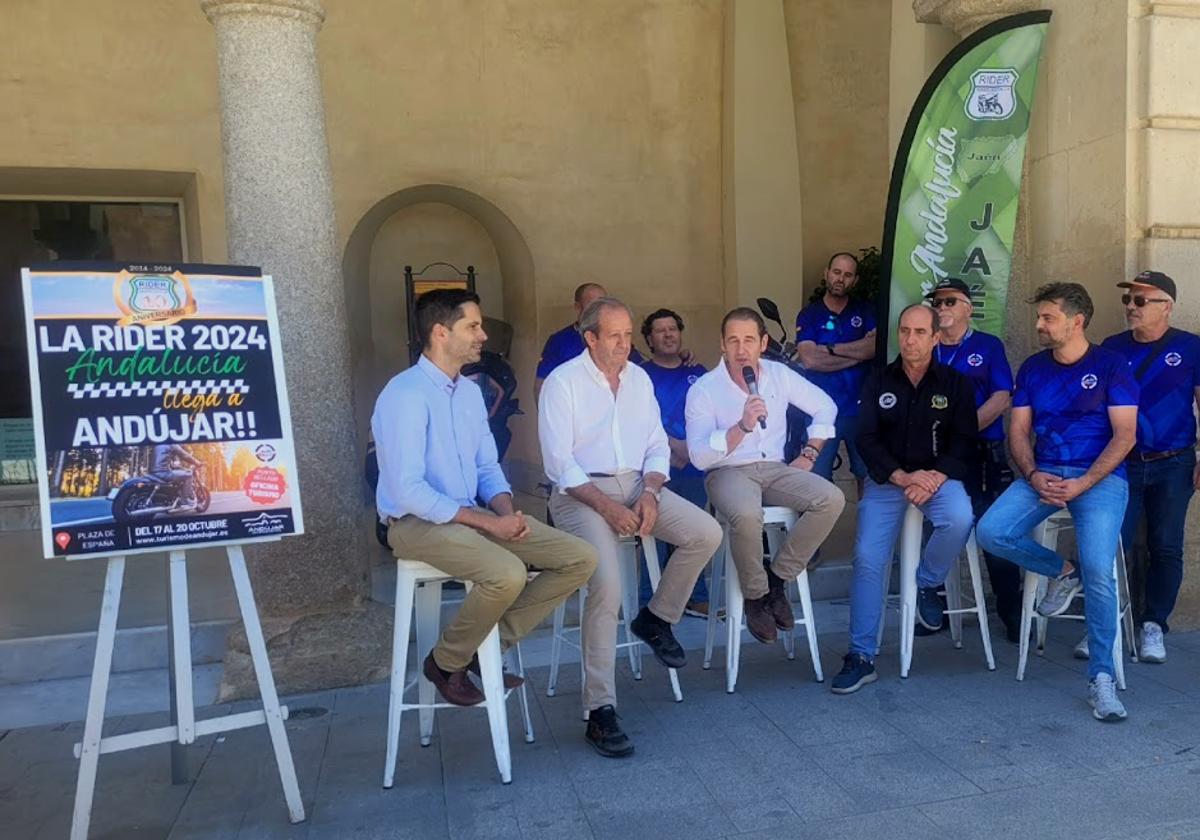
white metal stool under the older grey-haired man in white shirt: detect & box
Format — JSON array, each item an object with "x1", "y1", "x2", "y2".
[{"x1": 546, "y1": 536, "x2": 683, "y2": 720}]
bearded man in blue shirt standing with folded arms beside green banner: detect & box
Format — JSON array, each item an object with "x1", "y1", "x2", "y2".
[{"x1": 796, "y1": 253, "x2": 875, "y2": 499}]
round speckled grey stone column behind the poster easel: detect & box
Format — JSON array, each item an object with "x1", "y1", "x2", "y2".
[{"x1": 200, "y1": 0, "x2": 389, "y2": 697}]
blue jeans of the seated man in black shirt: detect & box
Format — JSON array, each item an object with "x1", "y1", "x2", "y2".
[{"x1": 850, "y1": 479, "x2": 974, "y2": 659}]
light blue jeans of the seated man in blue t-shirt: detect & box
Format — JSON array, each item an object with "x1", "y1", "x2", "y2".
[{"x1": 976, "y1": 467, "x2": 1129, "y2": 679}]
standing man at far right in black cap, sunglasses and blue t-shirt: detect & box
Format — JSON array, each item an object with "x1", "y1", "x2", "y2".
[{"x1": 1099, "y1": 271, "x2": 1200, "y2": 662}]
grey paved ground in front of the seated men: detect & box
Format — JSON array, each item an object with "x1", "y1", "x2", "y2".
[{"x1": 0, "y1": 619, "x2": 1200, "y2": 840}]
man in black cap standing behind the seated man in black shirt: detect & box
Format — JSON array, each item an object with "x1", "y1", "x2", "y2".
[{"x1": 925, "y1": 277, "x2": 1021, "y2": 642}]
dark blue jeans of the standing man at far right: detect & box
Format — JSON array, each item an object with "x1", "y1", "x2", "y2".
[{"x1": 1121, "y1": 450, "x2": 1195, "y2": 632}]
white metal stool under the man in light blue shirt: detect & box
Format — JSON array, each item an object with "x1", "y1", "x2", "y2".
[{"x1": 383, "y1": 559, "x2": 533, "y2": 787}]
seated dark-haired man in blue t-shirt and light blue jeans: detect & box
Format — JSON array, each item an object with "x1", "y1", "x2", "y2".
[{"x1": 976, "y1": 283, "x2": 1138, "y2": 721}]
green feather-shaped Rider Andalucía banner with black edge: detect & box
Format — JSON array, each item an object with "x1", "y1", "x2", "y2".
[{"x1": 877, "y1": 11, "x2": 1050, "y2": 360}]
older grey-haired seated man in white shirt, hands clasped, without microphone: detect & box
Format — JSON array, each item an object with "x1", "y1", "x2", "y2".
[{"x1": 538, "y1": 298, "x2": 721, "y2": 757}]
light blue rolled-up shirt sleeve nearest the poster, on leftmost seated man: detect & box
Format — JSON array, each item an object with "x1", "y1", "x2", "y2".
[{"x1": 371, "y1": 389, "x2": 458, "y2": 524}]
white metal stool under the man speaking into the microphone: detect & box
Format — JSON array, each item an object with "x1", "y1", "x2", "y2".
[{"x1": 703, "y1": 506, "x2": 824, "y2": 694}]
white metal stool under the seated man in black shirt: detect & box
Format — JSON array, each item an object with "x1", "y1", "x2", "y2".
[{"x1": 876, "y1": 504, "x2": 996, "y2": 678}]
